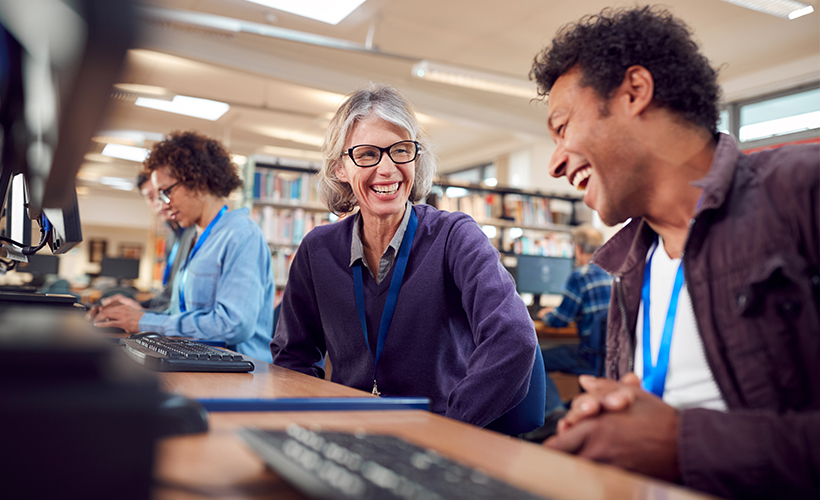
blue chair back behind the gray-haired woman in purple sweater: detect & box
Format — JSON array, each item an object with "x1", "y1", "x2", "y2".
[{"x1": 486, "y1": 348, "x2": 547, "y2": 436}]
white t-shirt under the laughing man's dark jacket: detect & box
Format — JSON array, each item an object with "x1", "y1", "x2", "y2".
[{"x1": 635, "y1": 237, "x2": 726, "y2": 410}]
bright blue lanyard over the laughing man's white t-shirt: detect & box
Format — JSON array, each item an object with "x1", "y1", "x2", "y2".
[{"x1": 641, "y1": 238, "x2": 684, "y2": 398}]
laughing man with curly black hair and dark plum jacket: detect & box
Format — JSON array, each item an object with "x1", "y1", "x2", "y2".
[{"x1": 531, "y1": 7, "x2": 820, "y2": 498}]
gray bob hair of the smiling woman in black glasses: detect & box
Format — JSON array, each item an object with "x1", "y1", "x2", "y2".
[{"x1": 318, "y1": 83, "x2": 436, "y2": 214}]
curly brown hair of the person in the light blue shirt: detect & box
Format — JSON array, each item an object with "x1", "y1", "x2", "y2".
[{"x1": 143, "y1": 131, "x2": 242, "y2": 198}]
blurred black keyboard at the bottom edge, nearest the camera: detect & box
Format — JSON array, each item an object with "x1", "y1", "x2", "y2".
[{"x1": 239, "y1": 425, "x2": 541, "y2": 500}]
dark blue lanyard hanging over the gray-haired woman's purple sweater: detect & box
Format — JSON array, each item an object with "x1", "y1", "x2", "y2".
[{"x1": 353, "y1": 207, "x2": 418, "y2": 396}]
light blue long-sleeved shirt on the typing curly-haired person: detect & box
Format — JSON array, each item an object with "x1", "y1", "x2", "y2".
[{"x1": 139, "y1": 208, "x2": 274, "y2": 363}]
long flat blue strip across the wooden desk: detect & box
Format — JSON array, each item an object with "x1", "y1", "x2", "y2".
[{"x1": 197, "y1": 397, "x2": 430, "y2": 411}]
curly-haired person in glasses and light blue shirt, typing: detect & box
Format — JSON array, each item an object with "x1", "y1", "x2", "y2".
[{"x1": 94, "y1": 132, "x2": 274, "y2": 362}]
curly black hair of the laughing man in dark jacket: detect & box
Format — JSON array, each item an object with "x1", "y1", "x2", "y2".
[{"x1": 530, "y1": 6, "x2": 720, "y2": 133}]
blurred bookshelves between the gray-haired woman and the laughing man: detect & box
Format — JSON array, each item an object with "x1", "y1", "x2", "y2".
[{"x1": 427, "y1": 179, "x2": 581, "y2": 257}]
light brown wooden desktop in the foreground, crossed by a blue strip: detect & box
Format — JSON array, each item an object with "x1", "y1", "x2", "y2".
[{"x1": 155, "y1": 363, "x2": 716, "y2": 500}]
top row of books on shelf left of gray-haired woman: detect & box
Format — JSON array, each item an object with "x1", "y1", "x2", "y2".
[{"x1": 253, "y1": 168, "x2": 319, "y2": 205}]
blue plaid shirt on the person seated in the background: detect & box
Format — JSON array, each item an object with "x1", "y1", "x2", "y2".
[{"x1": 544, "y1": 264, "x2": 612, "y2": 337}]
